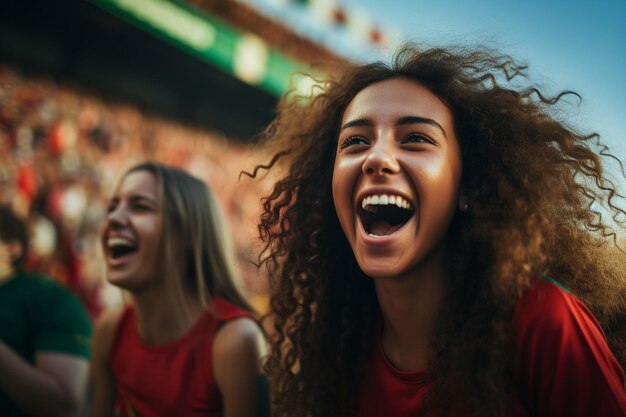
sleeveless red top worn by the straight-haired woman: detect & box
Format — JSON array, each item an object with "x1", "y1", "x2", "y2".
[{"x1": 111, "y1": 299, "x2": 252, "y2": 417}]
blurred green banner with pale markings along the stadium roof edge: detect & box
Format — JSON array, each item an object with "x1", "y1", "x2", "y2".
[{"x1": 87, "y1": 0, "x2": 308, "y2": 96}]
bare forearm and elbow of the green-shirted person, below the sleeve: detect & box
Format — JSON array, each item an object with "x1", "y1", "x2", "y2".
[{"x1": 0, "y1": 341, "x2": 89, "y2": 416}]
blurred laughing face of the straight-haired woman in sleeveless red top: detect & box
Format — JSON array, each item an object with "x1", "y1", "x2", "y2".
[{"x1": 101, "y1": 170, "x2": 162, "y2": 291}]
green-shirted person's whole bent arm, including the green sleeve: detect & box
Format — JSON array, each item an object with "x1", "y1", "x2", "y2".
[{"x1": 0, "y1": 278, "x2": 91, "y2": 416}]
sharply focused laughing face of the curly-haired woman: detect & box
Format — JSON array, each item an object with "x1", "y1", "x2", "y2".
[{"x1": 332, "y1": 77, "x2": 461, "y2": 278}]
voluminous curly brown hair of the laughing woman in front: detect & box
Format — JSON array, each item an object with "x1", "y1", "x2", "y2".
[{"x1": 250, "y1": 45, "x2": 626, "y2": 417}]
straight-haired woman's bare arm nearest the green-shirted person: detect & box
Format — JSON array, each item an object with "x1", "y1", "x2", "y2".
[{"x1": 91, "y1": 310, "x2": 122, "y2": 417}]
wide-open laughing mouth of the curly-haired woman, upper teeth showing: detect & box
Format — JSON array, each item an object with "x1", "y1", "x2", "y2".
[{"x1": 358, "y1": 194, "x2": 415, "y2": 237}]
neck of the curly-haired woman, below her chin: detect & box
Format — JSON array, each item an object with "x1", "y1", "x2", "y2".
[{"x1": 374, "y1": 244, "x2": 446, "y2": 371}]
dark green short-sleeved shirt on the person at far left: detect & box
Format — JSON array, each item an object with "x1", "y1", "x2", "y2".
[{"x1": 0, "y1": 272, "x2": 91, "y2": 417}]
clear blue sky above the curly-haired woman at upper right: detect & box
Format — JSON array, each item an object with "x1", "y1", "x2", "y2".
[{"x1": 342, "y1": 0, "x2": 626, "y2": 167}]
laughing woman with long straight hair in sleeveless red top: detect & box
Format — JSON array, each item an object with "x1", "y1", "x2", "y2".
[{"x1": 93, "y1": 163, "x2": 261, "y2": 417}]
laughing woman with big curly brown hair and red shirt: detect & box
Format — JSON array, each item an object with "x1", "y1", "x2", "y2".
[{"x1": 251, "y1": 47, "x2": 626, "y2": 417}]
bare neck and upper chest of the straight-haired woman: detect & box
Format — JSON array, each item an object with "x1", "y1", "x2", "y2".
[{"x1": 132, "y1": 291, "x2": 204, "y2": 345}]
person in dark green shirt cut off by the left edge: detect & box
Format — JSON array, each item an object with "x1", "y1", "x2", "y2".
[{"x1": 0, "y1": 207, "x2": 91, "y2": 417}]
